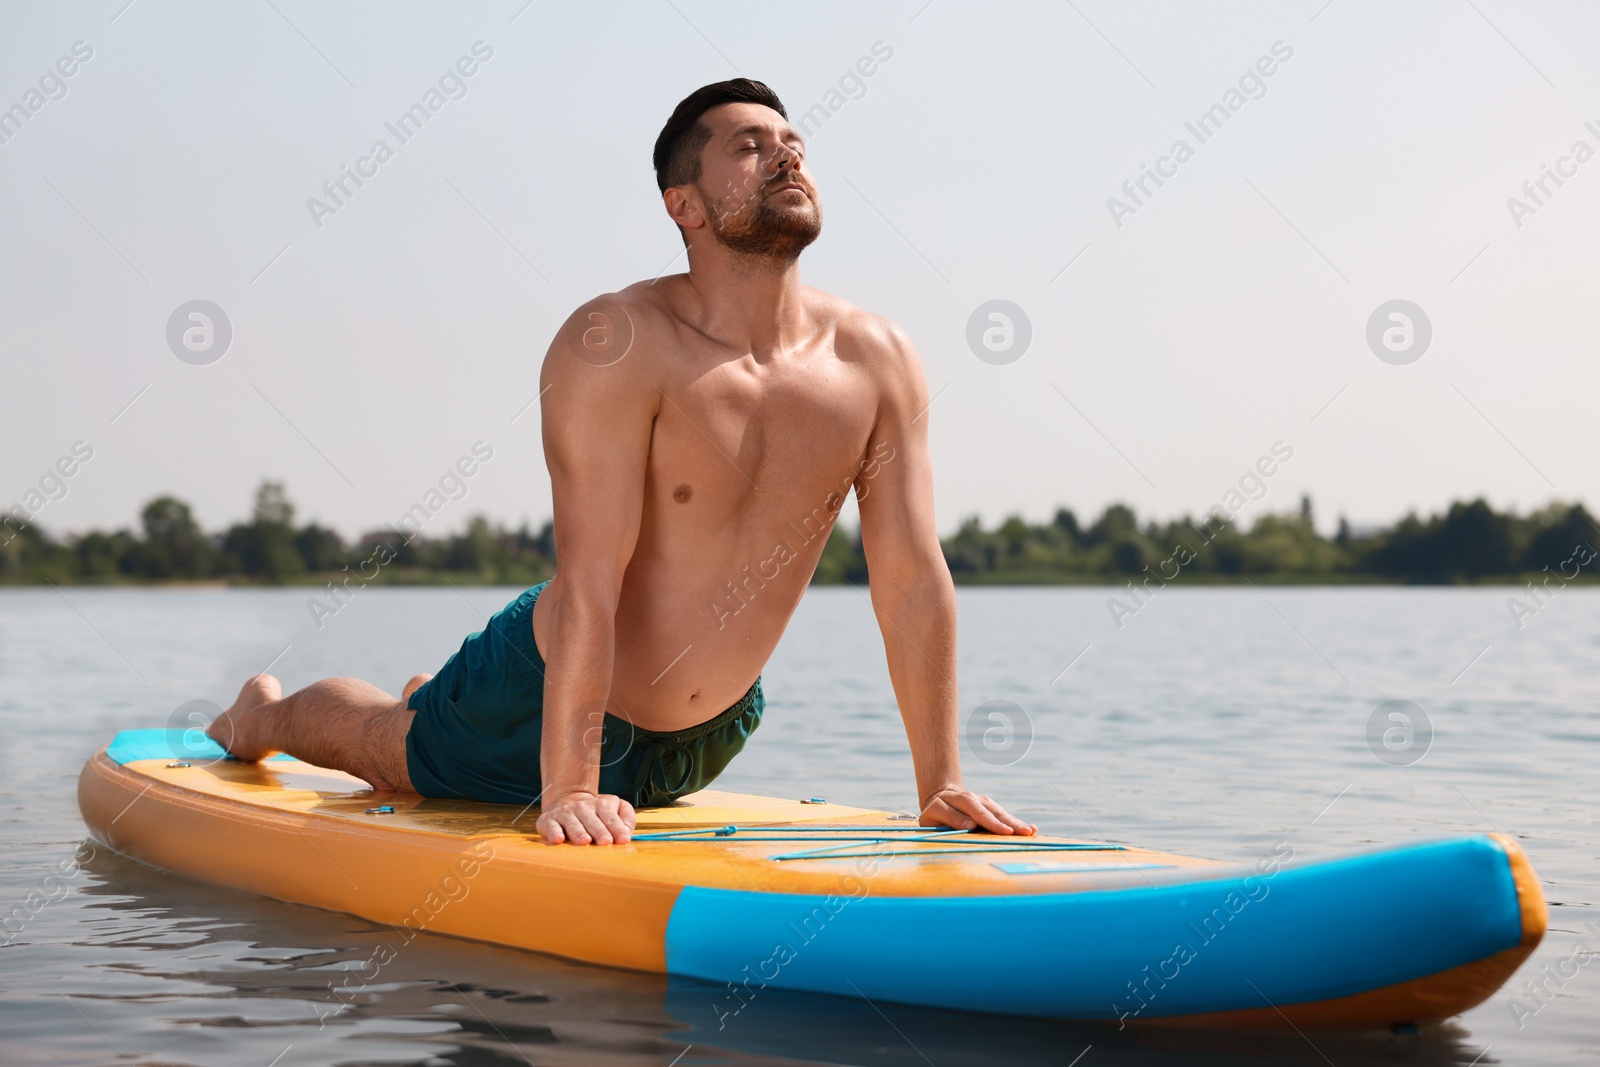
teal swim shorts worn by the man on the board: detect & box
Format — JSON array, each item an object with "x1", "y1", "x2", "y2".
[{"x1": 405, "y1": 582, "x2": 766, "y2": 808}]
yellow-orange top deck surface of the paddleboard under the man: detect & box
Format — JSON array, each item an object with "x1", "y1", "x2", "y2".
[{"x1": 107, "y1": 731, "x2": 1234, "y2": 896}]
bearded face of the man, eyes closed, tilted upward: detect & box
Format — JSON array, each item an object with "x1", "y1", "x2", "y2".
[{"x1": 694, "y1": 104, "x2": 822, "y2": 262}]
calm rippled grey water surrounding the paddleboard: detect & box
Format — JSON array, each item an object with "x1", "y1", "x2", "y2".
[{"x1": 0, "y1": 587, "x2": 1600, "y2": 1067}]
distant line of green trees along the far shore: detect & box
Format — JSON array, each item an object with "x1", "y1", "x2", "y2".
[{"x1": 0, "y1": 482, "x2": 1600, "y2": 585}]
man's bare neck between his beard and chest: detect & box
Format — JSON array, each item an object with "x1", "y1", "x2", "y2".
[{"x1": 688, "y1": 243, "x2": 808, "y2": 358}]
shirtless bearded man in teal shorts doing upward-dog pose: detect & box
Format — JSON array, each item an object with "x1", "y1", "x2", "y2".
[{"x1": 208, "y1": 78, "x2": 1035, "y2": 845}]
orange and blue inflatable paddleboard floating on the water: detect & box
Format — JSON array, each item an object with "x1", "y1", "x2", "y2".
[{"x1": 78, "y1": 729, "x2": 1547, "y2": 1030}]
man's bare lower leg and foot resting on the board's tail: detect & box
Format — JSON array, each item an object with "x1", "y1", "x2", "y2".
[{"x1": 206, "y1": 675, "x2": 427, "y2": 792}]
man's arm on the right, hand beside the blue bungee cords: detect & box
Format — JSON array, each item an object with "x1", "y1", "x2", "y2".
[{"x1": 856, "y1": 322, "x2": 1037, "y2": 835}]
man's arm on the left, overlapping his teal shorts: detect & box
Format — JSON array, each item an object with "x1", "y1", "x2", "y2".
[{"x1": 538, "y1": 298, "x2": 661, "y2": 845}]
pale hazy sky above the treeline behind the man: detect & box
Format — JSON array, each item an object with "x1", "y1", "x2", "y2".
[{"x1": 0, "y1": 0, "x2": 1600, "y2": 534}]
